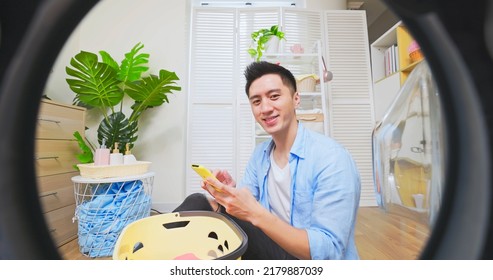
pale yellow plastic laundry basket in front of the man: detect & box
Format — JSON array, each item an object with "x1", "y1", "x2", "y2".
[{"x1": 113, "y1": 211, "x2": 248, "y2": 260}]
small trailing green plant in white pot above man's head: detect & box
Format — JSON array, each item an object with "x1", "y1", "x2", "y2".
[{"x1": 248, "y1": 25, "x2": 285, "y2": 61}]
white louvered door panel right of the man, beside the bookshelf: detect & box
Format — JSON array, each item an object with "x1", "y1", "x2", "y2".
[{"x1": 324, "y1": 11, "x2": 377, "y2": 206}]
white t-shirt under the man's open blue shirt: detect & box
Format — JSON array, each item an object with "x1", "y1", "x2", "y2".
[{"x1": 267, "y1": 150, "x2": 291, "y2": 223}]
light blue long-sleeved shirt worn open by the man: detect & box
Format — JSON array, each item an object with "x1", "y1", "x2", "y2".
[{"x1": 238, "y1": 123, "x2": 361, "y2": 259}]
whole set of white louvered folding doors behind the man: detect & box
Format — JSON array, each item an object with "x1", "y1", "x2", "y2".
[{"x1": 186, "y1": 8, "x2": 376, "y2": 206}]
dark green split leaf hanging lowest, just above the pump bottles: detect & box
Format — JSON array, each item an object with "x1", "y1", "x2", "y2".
[{"x1": 98, "y1": 112, "x2": 138, "y2": 153}]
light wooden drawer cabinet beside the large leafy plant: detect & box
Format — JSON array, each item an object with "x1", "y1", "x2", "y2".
[{"x1": 34, "y1": 99, "x2": 86, "y2": 246}]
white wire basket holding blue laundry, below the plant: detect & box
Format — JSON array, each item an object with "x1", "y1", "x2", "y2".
[{"x1": 72, "y1": 172, "x2": 154, "y2": 258}]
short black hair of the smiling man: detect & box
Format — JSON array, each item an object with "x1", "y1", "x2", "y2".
[{"x1": 245, "y1": 61, "x2": 297, "y2": 96}]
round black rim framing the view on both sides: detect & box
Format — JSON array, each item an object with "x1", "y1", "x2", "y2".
[{"x1": 0, "y1": 0, "x2": 493, "y2": 259}]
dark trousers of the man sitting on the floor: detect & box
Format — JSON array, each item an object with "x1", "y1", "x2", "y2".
[{"x1": 173, "y1": 193, "x2": 296, "y2": 260}]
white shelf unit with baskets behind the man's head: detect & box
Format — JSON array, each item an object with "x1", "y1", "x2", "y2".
[{"x1": 255, "y1": 40, "x2": 329, "y2": 143}]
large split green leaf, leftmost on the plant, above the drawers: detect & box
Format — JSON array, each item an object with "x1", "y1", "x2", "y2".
[{"x1": 66, "y1": 51, "x2": 123, "y2": 108}]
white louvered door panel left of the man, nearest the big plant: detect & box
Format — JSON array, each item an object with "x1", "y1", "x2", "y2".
[{"x1": 186, "y1": 8, "x2": 238, "y2": 195}]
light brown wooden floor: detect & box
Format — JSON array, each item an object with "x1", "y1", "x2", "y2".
[{"x1": 59, "y1": 207, "x2": 429, "y2": 260}]
